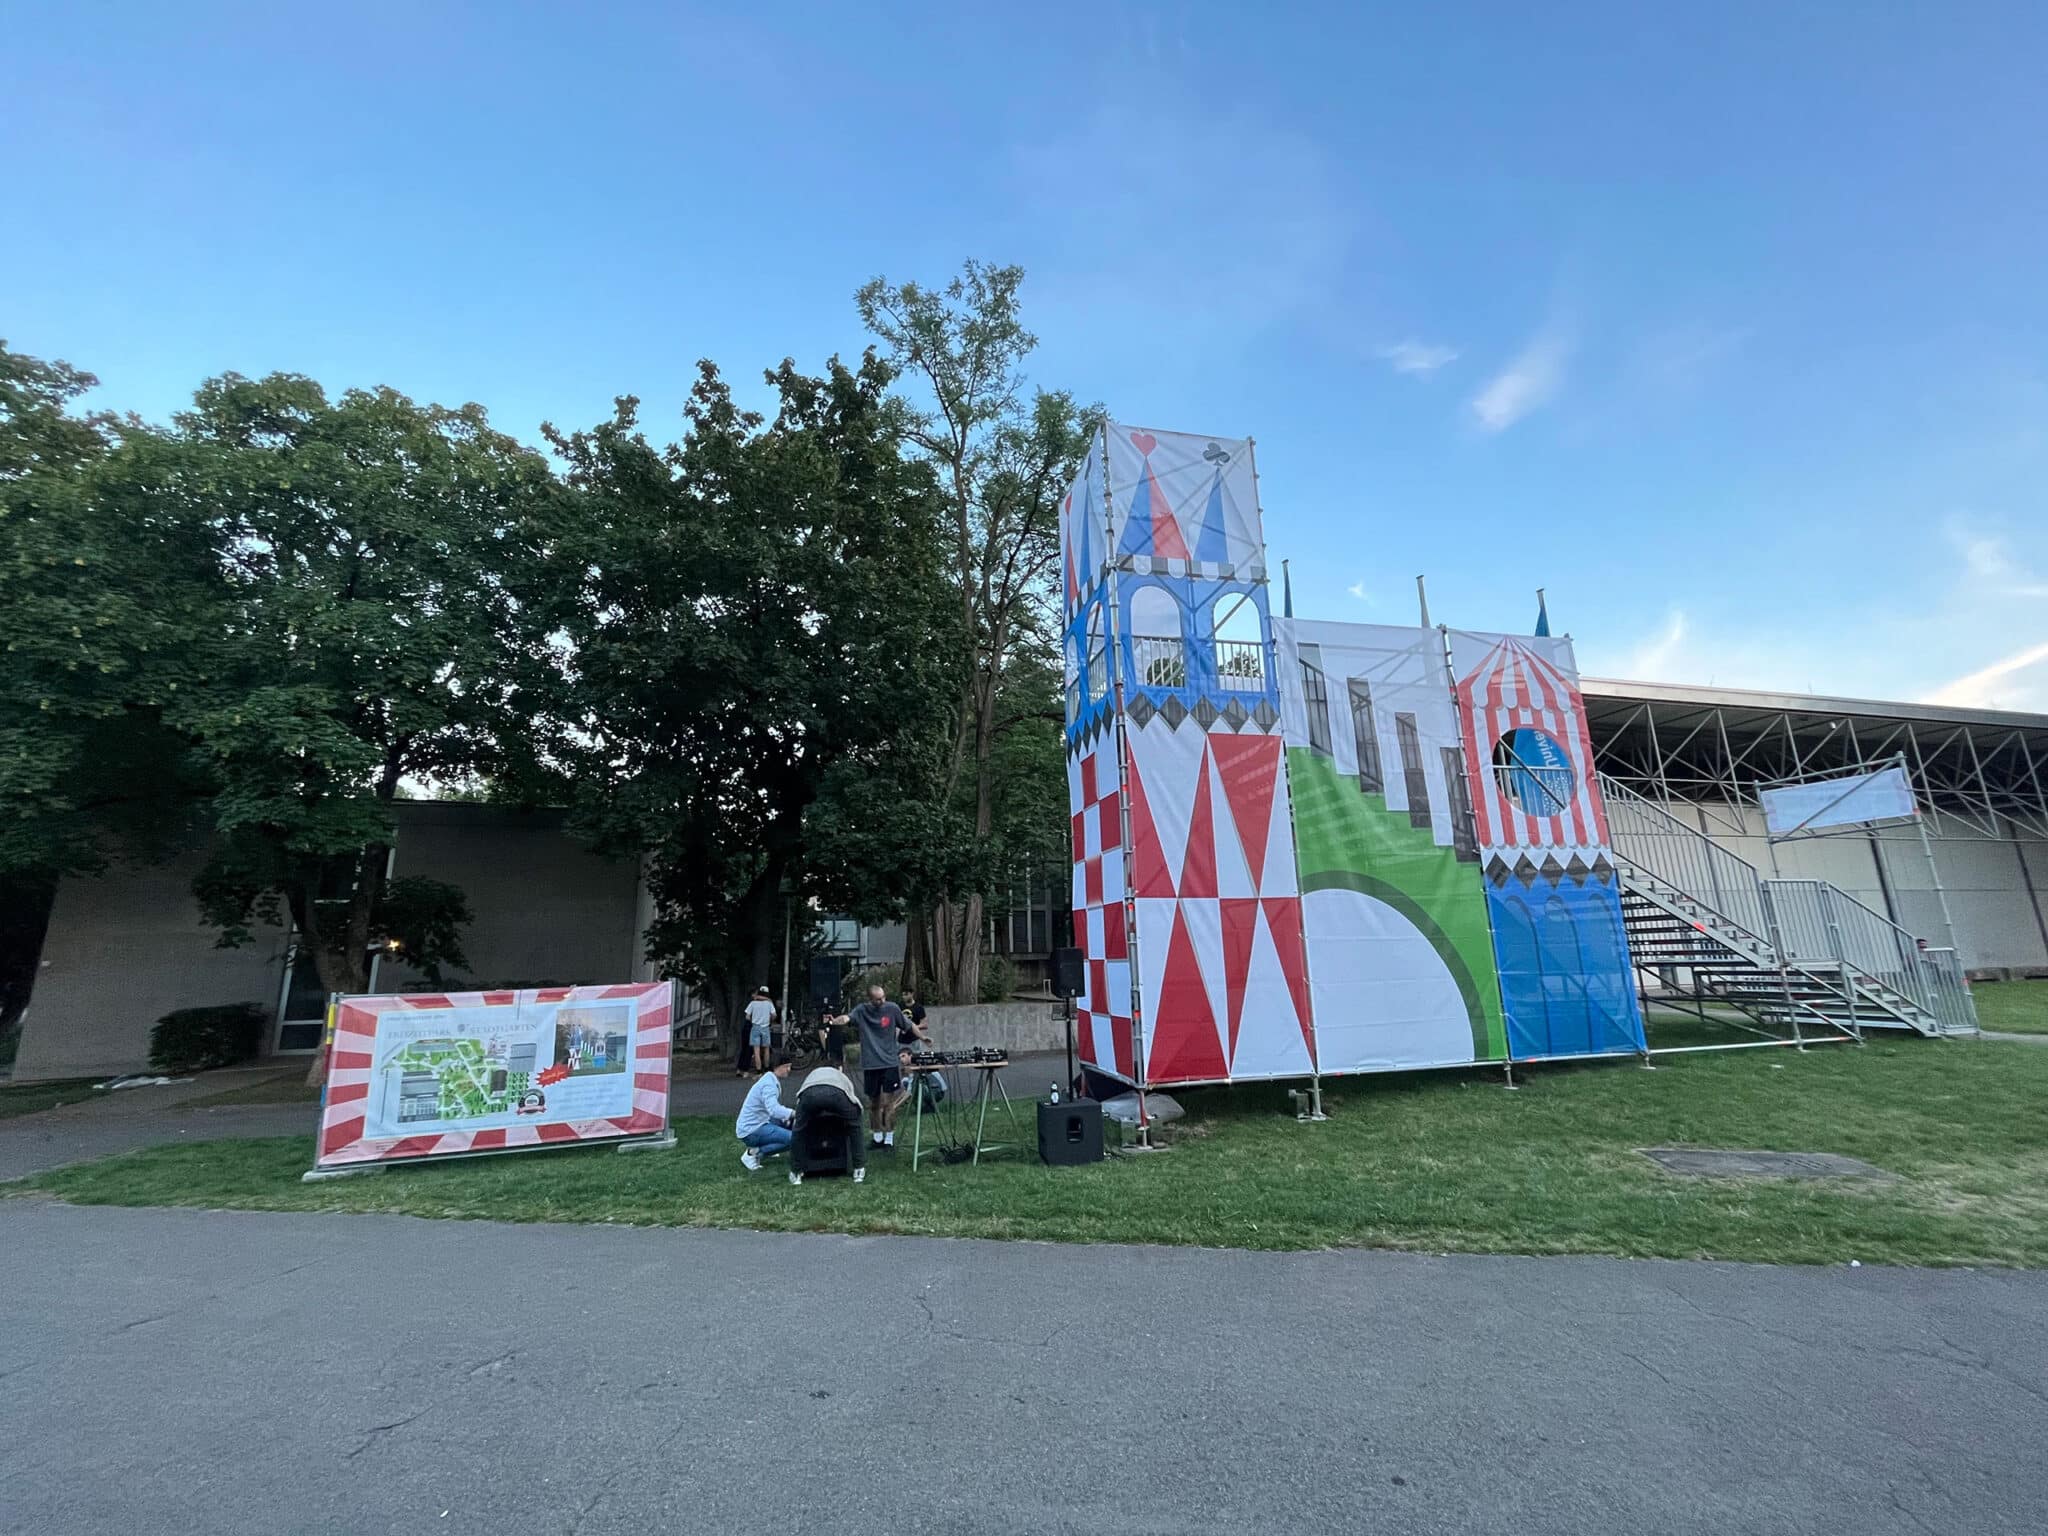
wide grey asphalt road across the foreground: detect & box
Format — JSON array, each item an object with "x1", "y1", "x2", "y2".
[{"x1": 0, "y1": 1198, "x2": 2048, "y2": 1536}]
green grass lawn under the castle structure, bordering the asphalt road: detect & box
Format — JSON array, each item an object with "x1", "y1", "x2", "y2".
[{"x1": 14, "y1": 1038, "x2": 2048, "y2": 1266}]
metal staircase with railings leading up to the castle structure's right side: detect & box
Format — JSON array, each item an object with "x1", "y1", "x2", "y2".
[{"x1": 1599, "y1": 774, "x2": 1976, "y2": 1040}]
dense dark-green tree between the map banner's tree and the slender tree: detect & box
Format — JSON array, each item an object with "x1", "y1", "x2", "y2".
[{"x1": 539, "y1": 356, "x2": 956, "y2": 1030}]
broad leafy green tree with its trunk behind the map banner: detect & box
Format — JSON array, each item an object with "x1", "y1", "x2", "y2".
[{"x1": 96, "y1": 375, "x2": 553, "y2": 1073}]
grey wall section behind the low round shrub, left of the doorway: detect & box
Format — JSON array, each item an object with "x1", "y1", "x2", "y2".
[{"x1": 14, "y1": 852, "x2": 285, "y2": 1081}]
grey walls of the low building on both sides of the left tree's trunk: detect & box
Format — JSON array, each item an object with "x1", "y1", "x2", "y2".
[{"x1": 14, "y1": 803, "x2": 649, "y2": 1081}]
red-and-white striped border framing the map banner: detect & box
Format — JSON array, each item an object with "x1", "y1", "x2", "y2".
[{"x1": 313, "y1": 981, "x2": 676, "y2": 1167}]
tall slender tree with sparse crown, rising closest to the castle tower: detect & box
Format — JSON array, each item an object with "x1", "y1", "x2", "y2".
[{"x1": 856, "y1": 262, "x2": 1102, "y2": 999}]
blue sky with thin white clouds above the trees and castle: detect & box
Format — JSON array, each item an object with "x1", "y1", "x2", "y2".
[{"x1": 0, "y1": 0, "x2": 2048, "y2": 709}]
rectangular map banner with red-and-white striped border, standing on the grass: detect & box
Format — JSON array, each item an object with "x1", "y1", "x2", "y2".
[{"x1": 313, "y1": 981, "x2": 676, "y2": 1167}]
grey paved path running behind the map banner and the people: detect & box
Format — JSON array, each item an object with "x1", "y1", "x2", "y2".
[{"x1": 0, "y1": 1055, "x2": 1067, "y2": 1180}]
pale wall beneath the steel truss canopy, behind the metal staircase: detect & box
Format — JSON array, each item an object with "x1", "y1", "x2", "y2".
[{"x1": 1665, "y1": 801, "x2": 2048, "y2": 973}]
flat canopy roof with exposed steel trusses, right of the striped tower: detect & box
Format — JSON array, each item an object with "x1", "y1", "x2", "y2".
[{"x1": 1583, "y1": 678, "x2": 2048, "y2": 838}]
